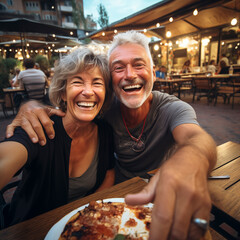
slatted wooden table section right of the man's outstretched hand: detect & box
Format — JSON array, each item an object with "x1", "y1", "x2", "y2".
[{"x1": 208, "y1": 142, "x2": 240, "y2": 239}]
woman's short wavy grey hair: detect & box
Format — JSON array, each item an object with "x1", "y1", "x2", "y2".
[{"x1": 49, "y1": 48, "x2": 112, "y2": 111}]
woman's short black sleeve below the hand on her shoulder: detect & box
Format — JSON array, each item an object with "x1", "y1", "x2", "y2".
[{"x1": 4, "y1": 127, "x2": 40, "y2": 165}]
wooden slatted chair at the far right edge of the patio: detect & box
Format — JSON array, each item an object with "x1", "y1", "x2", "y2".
[{"x1": 214, "y1": 78, "x2": 240, "y2": 108}]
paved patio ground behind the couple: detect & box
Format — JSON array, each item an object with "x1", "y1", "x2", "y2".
[{"x1": 0, "y1": 94, "x2": 240, "y2": 145}]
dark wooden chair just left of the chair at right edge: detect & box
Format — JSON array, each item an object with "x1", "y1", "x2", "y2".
[{"x1": 192, "y1": 77, "x2": 214, "y2": 104}]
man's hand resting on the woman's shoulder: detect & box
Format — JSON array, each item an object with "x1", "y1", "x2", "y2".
[{"x1": 6, "y1": 101, "x2": 65, "y2": 146}]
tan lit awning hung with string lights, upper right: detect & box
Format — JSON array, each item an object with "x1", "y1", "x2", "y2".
[{"x1": 84, "y1": 0, "x2": 240, "y2": 41}]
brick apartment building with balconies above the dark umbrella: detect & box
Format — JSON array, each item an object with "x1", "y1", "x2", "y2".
[{"x1": 0, "y1": 0, "x2": 97, "y2": 30}]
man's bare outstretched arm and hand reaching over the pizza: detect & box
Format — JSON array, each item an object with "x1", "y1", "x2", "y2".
[{"x1": 125, "y1": 124, "x2": 217, "y2": 240}]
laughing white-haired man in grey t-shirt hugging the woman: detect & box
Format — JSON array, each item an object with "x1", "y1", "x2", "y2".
[{"x1": 7, "y1": 31, "x2": 216, "y2": 240}]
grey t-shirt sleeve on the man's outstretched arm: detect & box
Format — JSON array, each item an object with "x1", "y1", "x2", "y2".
[{"x1": 169, "y1": 101, "x2": 199, "y2": 131}]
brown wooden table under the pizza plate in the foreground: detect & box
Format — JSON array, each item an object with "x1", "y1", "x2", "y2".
[{"x1": 0, "y1": 142, "x2": 240, "y2": 240}]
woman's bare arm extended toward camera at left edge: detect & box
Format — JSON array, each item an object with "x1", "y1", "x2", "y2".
[{"x1": 0, "y1": 141, "x2": 28, "y2": 189}]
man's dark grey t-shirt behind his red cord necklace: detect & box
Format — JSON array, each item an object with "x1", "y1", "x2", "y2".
[{"x1": 105, "y1": 91, "x2": 198, "y2": 183}]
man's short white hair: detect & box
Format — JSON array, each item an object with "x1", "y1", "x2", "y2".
[{"x1": 108, "y1": 30, "x2": 153, "y2": 66}]
